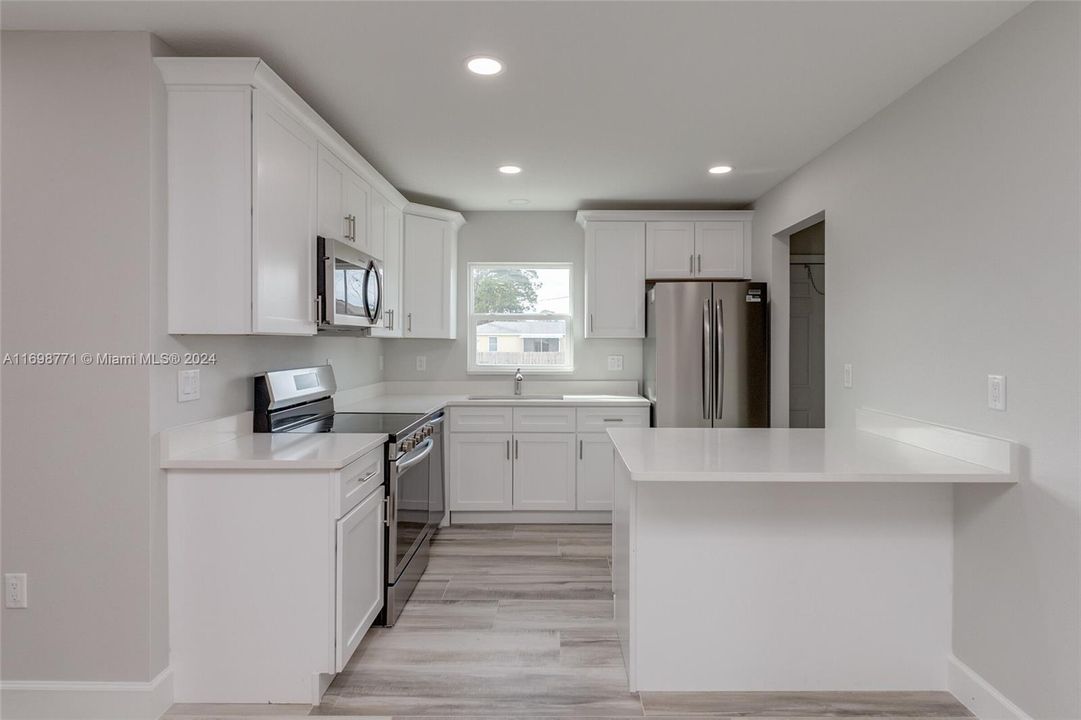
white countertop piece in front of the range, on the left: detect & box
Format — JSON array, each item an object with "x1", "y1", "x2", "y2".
[{"x1": 161, "y1": 432, "x2": 387, "y2": 470}]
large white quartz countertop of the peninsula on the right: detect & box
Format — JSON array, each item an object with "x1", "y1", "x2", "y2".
[{"x1": 609, "y1": 428, "x2": 1016, "y2": 483}]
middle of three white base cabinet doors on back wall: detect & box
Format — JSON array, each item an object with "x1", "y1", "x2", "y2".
[{"x1": 513, "y1": 432, "x2": 576, "y2": 510}]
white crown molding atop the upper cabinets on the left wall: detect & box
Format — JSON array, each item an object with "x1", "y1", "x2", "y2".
[{"x1": 154, "y1": 57, "x2": 409, "y2": 209}]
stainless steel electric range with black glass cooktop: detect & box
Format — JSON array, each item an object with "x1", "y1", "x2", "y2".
[{"x1": 254, "y1": 365, "x2": 446, "y2": 626}]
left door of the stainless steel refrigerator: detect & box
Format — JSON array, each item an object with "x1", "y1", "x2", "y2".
[{"x1": 645, "y1": 282, "x2": 713, "y2": 427}]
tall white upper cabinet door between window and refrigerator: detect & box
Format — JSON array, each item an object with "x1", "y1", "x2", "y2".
[{"x1": 585, "y1": 223, "x2": 645, "y2": 337}]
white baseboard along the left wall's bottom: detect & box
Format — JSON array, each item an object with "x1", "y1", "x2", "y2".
[{"x1": 0, "y1": 667, "x2": 173, "y2": 720}]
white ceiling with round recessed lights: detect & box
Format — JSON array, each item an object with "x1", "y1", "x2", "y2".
[{"x1": 2, "y1": 0, "x2": 1024, "y2": 210}]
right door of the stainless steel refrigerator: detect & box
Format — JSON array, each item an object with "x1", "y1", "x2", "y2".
[{"x1": 712, "y1": 281, "x2": 770, "y2": 427}]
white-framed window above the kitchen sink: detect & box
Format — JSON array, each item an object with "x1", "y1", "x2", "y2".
[{"x1": 468, "y1": 263, "x2": 574, "y2": 373}]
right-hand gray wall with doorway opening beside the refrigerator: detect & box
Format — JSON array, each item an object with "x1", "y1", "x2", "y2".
[{"x1": 755, "y1": 3, "x2": 1081, "y2": 719}]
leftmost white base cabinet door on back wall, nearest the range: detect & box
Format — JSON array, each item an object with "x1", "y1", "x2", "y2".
[{"x1": 446, "y1": 432, "x2": 513, "y2": 510}]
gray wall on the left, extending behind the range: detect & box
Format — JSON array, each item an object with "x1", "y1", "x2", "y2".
[{"x1": 0, "y1": 31, "x2": 382, "y2": 681}]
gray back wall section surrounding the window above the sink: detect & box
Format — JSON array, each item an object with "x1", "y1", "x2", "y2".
[{"x1": 384, "y1": 211, "x2": 642, "y2": 382}]
